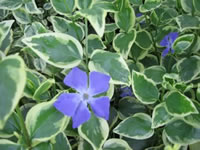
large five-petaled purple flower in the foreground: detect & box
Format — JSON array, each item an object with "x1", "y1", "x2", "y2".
[{"x1": 54, "y1": 67, "x2": 110, "y2": 128}]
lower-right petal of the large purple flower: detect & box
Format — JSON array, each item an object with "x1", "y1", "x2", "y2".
[{"x1": 88, "y1": 96, "x2": 110, "y2": 120}]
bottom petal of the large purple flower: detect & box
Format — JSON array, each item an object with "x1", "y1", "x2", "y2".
[{"x1": 72, "y1": 101, "x2": 90, "y2": 128}]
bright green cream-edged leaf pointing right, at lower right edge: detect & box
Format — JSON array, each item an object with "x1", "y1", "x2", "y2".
[{"x1": 164, "y1": 91, "x2": 198, "y2": 117}]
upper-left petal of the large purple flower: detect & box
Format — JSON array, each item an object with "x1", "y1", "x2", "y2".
[{"x1": 64, "y1": 67, "x2": 88, "y2": 93}]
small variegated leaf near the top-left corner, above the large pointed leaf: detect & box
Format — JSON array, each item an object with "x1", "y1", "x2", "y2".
[{"x1": 13, "y1": 7, "x2": 31, "y2": 24}]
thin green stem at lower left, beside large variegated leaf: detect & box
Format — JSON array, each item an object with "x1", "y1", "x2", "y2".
[{"x1": 16, "y1": 105, "x2": 31, "y2": 150}]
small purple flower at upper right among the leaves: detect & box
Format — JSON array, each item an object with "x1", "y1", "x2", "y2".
[{"x1": 160, "y1": 32, "x2": 178, "y2": 57}]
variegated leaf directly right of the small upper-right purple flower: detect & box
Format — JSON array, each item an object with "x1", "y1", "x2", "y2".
[{"x1": 173, "y1": 34, "x2": 195, "y2": 54}]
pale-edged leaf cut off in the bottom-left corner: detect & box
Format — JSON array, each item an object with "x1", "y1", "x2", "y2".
[{"x1": 0, "y1": 139, "x2": 20, "y2": 150}]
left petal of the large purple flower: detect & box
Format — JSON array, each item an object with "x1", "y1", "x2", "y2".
[{"x1": 54, "y1": 93, "x2": 81, "y2": 117}]
